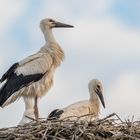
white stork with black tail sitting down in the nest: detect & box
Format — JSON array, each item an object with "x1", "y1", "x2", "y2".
[{"x1": 47, "y1": 79, "x2": 105, "y2": 120}]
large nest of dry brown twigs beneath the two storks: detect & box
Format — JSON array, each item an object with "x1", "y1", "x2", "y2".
[{"x1": 0, "y1": 113, "x2": 140, "y2": 140}]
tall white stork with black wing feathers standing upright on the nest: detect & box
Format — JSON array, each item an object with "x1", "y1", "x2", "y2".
[{"x1": 0, "y1": 18, "x2": 73, "y2": 124}]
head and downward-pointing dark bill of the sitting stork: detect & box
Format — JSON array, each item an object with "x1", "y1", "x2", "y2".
[{"x1": 88, "y1": 79, "x2": 105, "y2": 108}]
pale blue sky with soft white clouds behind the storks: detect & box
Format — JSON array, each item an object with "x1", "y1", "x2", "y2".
[{"x1": 0, "y1": 0, "x2": 140, "y2": 128}]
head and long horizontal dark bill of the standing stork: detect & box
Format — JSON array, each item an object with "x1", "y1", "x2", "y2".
[{"x1": 40, "y1": 18, "x2": 74, "y2": 31}]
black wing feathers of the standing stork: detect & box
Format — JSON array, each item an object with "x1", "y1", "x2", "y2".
[{"x1": 0, "y1": 72, "x2": 44, "y2": 106}]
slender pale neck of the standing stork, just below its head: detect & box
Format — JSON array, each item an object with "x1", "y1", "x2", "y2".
[{"x1": 43, "y1": 28, "x2": 56, "y2": 43}]
